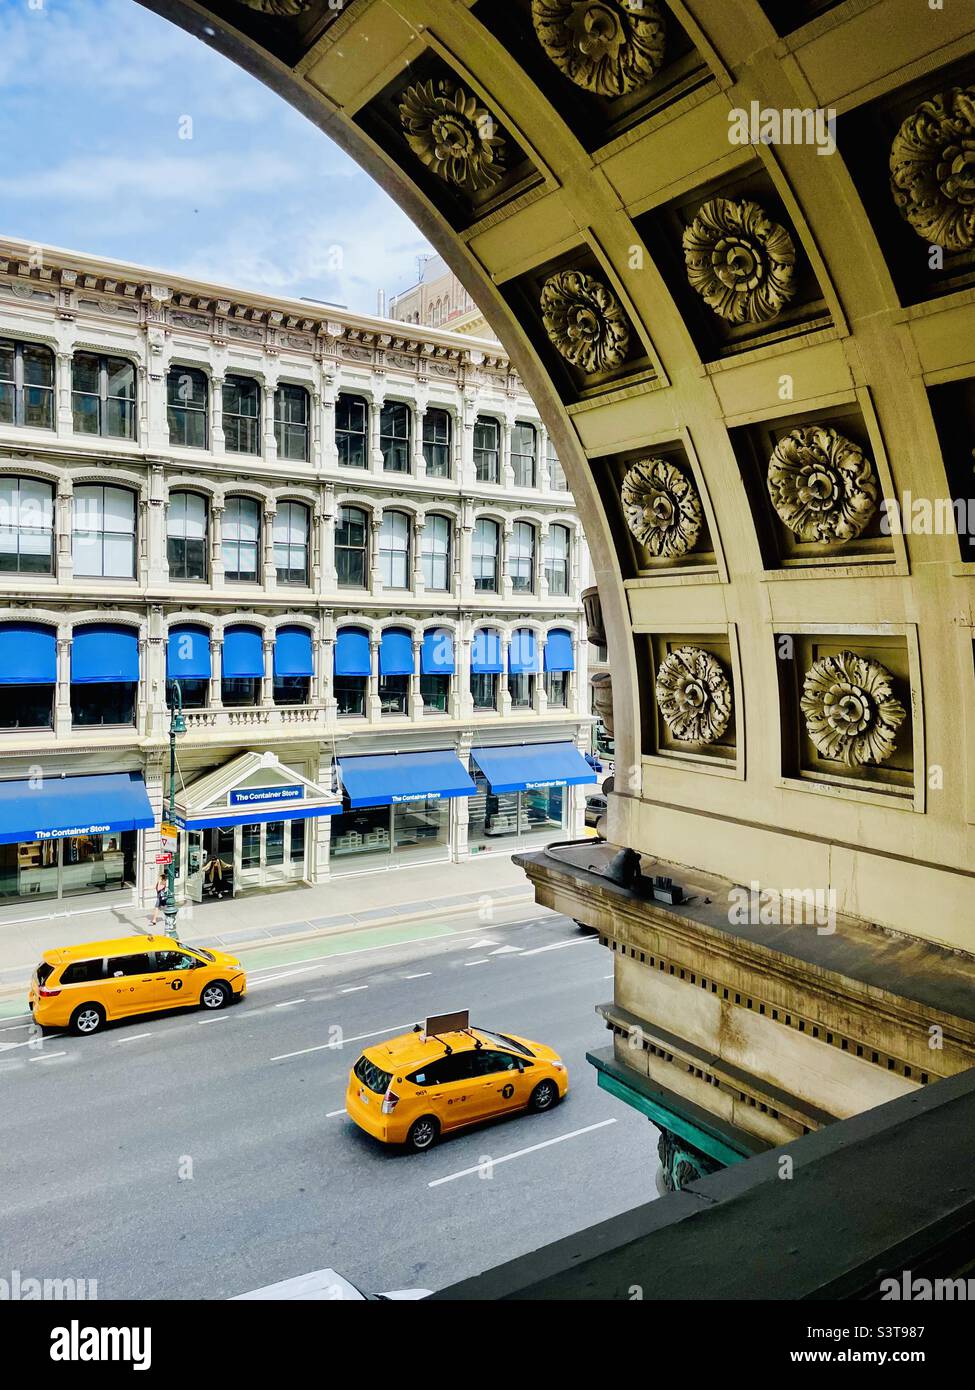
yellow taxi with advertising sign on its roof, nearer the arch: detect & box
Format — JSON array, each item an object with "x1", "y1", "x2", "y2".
[{"x1": 345, "y1": 1013, "x2": 569, "y2": 1152}]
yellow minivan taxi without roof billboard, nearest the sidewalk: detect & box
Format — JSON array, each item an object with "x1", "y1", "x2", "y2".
[{"x1": 28, "y1": 937, "x2": 248, "y2": 1034}]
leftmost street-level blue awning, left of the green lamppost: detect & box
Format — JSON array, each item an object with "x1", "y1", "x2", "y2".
[{"x1": 0, "y1": 773, "x2": 154, "y2": 845}]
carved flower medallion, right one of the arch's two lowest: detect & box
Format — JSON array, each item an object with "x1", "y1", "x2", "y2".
[{"x1": 800, "y1": 652, "x2": 907, "y2": 767}]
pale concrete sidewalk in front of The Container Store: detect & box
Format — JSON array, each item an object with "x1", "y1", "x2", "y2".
[{"x1": 0, "y1": 856, "x2": 534, "y2": 992}]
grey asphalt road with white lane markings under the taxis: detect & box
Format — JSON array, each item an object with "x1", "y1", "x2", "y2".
[{"x1": 0, "y1": 909, "x2": 656, "y2": 1298}]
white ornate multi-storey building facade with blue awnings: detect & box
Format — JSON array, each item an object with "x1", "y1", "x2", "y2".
[{"x1": 0, "y1": 242, "x2": 591, "y2": 917}]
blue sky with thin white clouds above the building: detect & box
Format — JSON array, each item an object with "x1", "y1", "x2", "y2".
[{"x1": 0, "y1": 0, "x2": 428, "y2": 313}]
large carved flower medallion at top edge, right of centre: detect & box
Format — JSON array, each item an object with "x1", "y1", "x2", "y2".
[{"x1": 531, "y1": 0, "x2": 666, "y2": 97}]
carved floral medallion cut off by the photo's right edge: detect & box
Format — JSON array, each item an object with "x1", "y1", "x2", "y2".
[{"x1": 890, "y1": 88, "x2": 975, "y2": 252}]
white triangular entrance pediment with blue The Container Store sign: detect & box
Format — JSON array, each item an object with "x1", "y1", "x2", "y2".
[{"x1": 175, "y1": 752, "x2": 342, "y2": 830}]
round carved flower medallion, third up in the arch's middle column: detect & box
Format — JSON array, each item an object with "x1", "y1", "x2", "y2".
[{"x1": 683, "y1": 197, "x2": 796, "y2": 324}]
